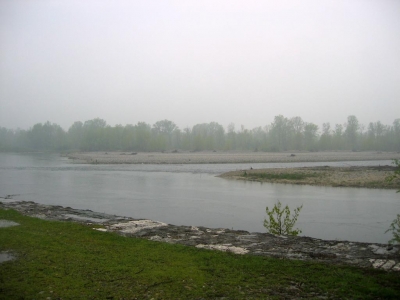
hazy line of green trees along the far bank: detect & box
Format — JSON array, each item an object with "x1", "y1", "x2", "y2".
[{"x1": 0, "y1": 115, "x2": 400, "y2": 152}]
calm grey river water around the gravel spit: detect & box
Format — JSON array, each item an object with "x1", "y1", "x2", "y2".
[{"x1": 0, "y1": 153, "x2": 400, "y2": 243}]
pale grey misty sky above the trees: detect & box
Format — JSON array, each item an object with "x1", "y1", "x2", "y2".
[{"x1": 0, "y1": 0, "x2": 400, "y2": 129}]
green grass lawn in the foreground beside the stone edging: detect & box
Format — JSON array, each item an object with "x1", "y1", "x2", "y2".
[{"x1": 0, "y1": 210, "x2": 400, "y2": 299}]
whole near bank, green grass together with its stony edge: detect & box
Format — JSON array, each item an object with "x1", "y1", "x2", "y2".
[{"x1": 0, "y1": 202, "x2": 400, "y2": 300}]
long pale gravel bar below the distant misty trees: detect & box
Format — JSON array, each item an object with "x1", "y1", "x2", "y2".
[{"x1": 67, "y1": 151, "x2": 400, "y2": 164}]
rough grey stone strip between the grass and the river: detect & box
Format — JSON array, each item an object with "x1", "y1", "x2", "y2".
[{"x1": 0, "y1": 201, "x2": 400, "y2": 272}]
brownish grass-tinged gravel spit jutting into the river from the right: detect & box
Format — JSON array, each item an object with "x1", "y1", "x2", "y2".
[{"x1": 219, "y1": 166, "x2": 400, "y2": 189}]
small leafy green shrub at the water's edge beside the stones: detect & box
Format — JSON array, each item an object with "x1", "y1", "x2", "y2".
[{"x1": 264, "y1": 201, "x2": 303, "y2": 235}]
